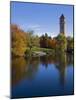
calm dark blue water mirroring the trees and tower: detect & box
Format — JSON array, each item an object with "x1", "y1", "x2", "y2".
[{"x1": 11, "y1": 54, "x2": 74, "y2": 98}]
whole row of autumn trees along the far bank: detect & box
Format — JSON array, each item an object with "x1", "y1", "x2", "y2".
[{"x1": 11, "y1": 24, "x2": 74, "y2": 56}]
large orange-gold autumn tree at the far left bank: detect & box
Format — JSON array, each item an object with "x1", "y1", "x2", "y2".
[{"x1": 11, "y1": 25, "x2": 27, "y2": 56}]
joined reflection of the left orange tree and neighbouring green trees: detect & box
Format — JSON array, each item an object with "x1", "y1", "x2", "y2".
[{"x1": 11, "y1": 57, "x2": 39, "y2": 85}]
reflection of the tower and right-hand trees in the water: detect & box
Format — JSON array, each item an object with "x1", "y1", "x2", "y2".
[{"x1": 55, "y1": 52, "x2": 73, "y2": 85}]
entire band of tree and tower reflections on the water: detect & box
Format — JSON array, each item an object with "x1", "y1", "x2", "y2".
[{"x1": 12, "y1": 53, "x2": 73, "y2": 84}]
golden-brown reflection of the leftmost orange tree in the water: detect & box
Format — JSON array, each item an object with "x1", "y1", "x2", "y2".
[{"x1": 12, "y1": 57, "x2": 28, "y2": 84}]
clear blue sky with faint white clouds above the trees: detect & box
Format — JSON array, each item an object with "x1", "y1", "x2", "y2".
[{"x1": 11, "y1": 2, "x2": 73, "y2": 37}]
